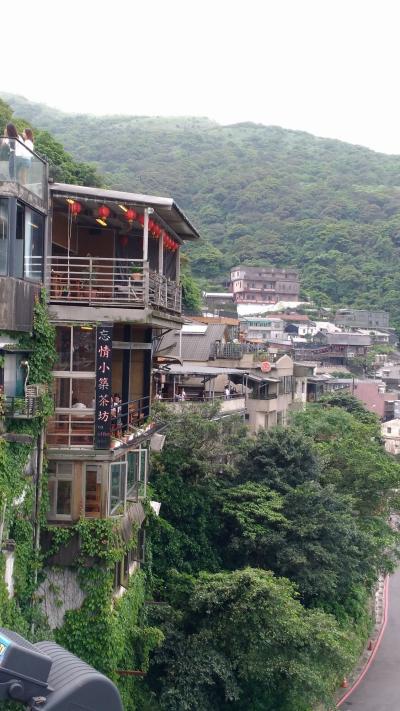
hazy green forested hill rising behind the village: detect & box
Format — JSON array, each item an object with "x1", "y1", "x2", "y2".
[{"x1": 3, "y1": 95, "x2": 400, "y2": 321}]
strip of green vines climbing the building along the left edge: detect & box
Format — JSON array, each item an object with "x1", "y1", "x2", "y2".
[{"x1": 0, "y1": 294, "x2": 55, "y2": 652}]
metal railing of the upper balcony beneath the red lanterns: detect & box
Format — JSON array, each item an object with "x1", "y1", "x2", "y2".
[{"x1": 47, "y1": 257, "x2": 181, "y2": 313}]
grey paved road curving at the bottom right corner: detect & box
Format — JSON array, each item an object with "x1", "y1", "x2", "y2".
[{"x1": 339, "y1": 568, "x2": 400, "y2": 711}]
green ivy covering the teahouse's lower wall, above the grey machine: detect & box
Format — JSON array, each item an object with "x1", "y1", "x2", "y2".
[{"x1": 52, "y1": 519, "x2": 163, "y2": 711}]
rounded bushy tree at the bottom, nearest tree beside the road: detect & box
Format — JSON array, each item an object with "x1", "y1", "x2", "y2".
[{"x1": 151, "y1": 568, "x2": 351, "y2": 711}]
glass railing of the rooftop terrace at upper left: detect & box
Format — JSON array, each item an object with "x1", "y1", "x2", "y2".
[{"x1": 0, "y1": 138, "x2": 47, "y2": 201}]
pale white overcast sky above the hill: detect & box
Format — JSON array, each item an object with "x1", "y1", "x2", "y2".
[{"x1": 0, "y1": 0, "x2": 400, "y2": 153}]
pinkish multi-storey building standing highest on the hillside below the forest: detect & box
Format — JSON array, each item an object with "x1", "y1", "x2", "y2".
[{"x1": 230, "y1": 266, "x2": 300, "y2": 304}]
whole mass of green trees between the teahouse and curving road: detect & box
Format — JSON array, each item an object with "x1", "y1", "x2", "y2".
[{"x1": 141, "y1": 394, "x2": 400, "y2": 711}]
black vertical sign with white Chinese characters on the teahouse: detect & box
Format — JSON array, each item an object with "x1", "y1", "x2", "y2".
[{"x1": 95, "y1": 326, "x2": 113, "y2": 449}]
